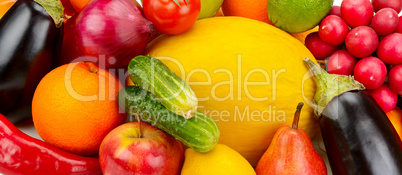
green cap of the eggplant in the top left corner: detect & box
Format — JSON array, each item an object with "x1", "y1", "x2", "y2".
[{"x1": 34, "y1": 0, "x2": 64, "y2": 28}]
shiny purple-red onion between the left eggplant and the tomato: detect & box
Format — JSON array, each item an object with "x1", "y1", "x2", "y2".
[{"x1": 75, "y1": 0, "x2": 153, "y2": 68}]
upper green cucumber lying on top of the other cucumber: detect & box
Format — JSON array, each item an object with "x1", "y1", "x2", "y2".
[{"x1": 128, "y1": 55, "x2": 198, "y2": 119}]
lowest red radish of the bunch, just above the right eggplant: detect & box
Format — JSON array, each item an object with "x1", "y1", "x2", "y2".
[{"x1": 368, "y1": 83, "x2": 398, "y2": 112}]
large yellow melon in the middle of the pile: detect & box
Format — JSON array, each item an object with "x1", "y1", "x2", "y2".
[{"x1": 146, "y1": 17, "x2": 318, "y2": 166}]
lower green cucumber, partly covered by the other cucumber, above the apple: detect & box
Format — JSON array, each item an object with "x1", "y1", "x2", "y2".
[{"x1": 118, "y1": 86, "x2": 220, "y2": 153}]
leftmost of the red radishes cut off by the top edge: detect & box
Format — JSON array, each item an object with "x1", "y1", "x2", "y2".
[{"x1": 341, "y1": 0, "x2": 374, "y2": 28}]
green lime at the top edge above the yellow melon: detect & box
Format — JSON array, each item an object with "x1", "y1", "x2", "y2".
[{"x1": 267, "y1": 0, "x2": 334, "y2": 33}]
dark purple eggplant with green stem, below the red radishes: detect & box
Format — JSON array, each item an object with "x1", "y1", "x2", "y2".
[{"x1": 304, "y1": 58, "x2": 402, "y2": 175}]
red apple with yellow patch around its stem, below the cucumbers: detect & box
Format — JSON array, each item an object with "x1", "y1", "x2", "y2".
[{"x1": 99, "y1": 122, "x2": 184, "y2": 175}]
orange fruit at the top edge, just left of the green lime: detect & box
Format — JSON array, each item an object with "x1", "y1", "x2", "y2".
[{"x1": 222, "y1": 0, "x2": 272, "y2": 24}]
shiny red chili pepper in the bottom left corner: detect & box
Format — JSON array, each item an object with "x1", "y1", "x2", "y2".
[{"x1": 0, "y1": 114, "x2": 102, "y2": 175}]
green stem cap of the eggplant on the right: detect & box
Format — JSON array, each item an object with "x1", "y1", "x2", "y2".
[{"x1": 303, "y1": 58, "x2": 366, "y2": 117}]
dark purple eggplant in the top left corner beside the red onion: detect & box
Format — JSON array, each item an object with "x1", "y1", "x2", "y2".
[{"x1": 0, "y1": 0, "x2": 63, "y2": 123}]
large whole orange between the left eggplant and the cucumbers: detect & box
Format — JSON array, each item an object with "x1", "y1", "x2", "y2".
[{"x1": 32, "y1": 62, "x2": 126, "y2": 155}]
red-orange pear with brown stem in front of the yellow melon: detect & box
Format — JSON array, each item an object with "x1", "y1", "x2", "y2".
[{"x1": 256, "y1": 103, "x2": 327, "y2": 175}]
